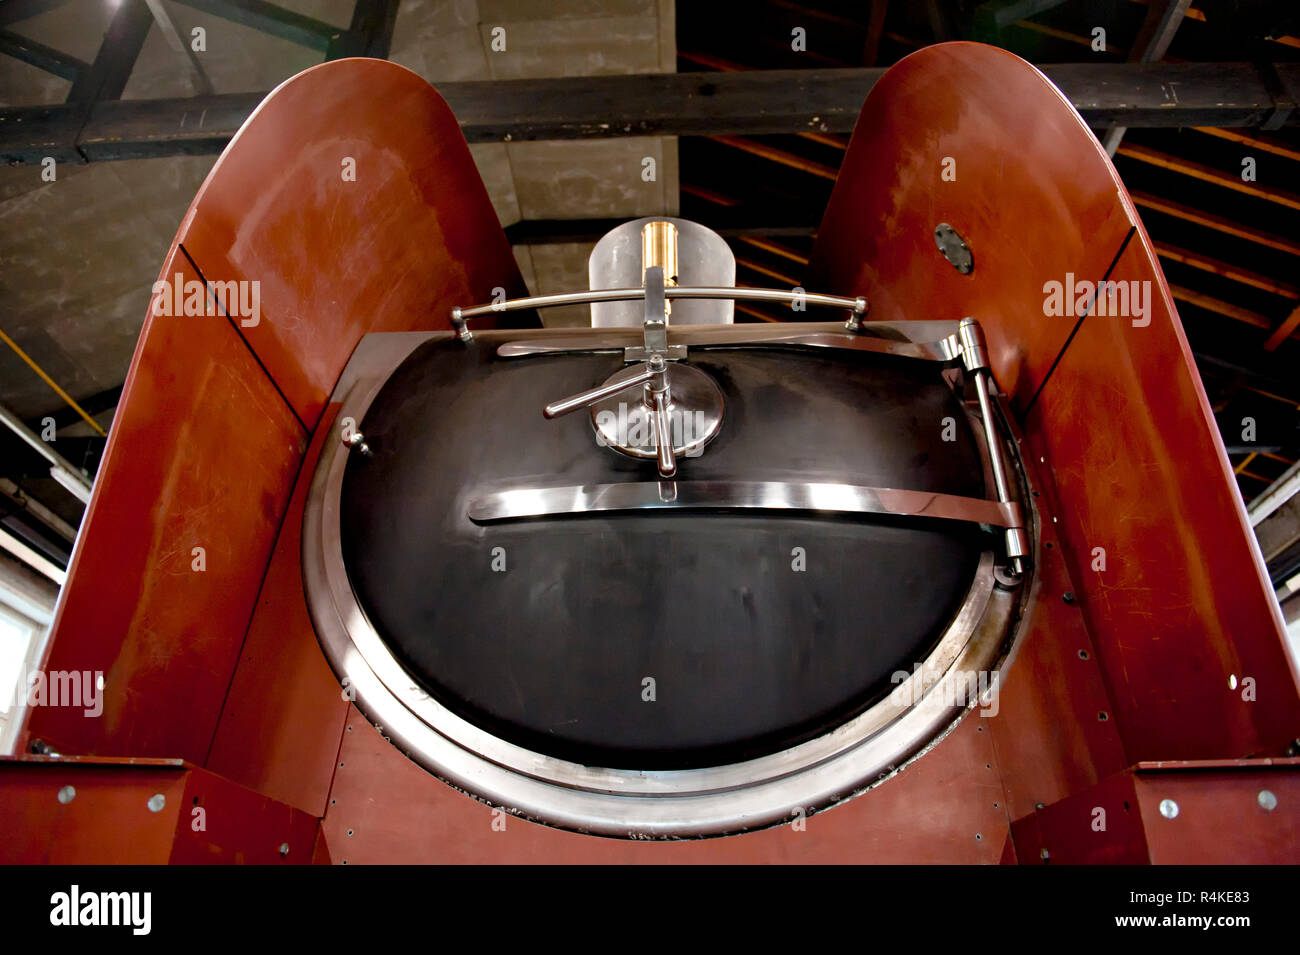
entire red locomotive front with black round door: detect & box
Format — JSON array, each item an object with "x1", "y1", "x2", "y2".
[{"x1": 0, "y1": 43, "x2": 1300, "y2": 864}]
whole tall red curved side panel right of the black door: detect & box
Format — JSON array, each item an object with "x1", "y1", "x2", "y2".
[{"x1": 807, "y1": 43, "x2": 1300, "y2": 761}]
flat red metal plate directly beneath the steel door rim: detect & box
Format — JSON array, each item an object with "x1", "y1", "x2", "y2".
[{"x1": 321, "y1": 709, "x2": 1014, "y2": 864}]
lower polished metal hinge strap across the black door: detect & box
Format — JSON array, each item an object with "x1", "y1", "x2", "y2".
[{"x1": 469, "y1": 481, "x2": 1021, "y2": 528}]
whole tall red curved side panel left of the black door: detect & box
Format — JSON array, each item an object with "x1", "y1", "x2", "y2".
[{"x1": 27, "y1": 60, "x2": 524, "y2": 764}]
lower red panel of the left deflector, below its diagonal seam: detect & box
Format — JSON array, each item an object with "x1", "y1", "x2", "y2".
[{"x1": 29, "y1": 246, "x2": 306, "y2": 761}]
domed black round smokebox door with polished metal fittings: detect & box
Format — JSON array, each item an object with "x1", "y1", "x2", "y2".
[{"x1": 341, "y1": 340, "x2": 988, "y2": 769}]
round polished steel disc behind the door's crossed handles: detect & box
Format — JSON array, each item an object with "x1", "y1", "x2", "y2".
[{"x1": 592, "y1": 363, "x2": 724, "y2": 459}]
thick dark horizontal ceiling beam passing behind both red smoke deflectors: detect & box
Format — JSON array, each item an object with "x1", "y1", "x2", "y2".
[{"x1": 0, "y1": 61, "x2": 1300, "y2": 162}]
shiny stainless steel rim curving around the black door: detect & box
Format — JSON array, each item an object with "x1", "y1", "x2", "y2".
[{"x1": 303, "y1": 328, "x2": 1023, "y2": 838}]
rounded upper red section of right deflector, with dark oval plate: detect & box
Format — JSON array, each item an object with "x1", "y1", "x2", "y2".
[{"x1": 805, "y1": 43, "x2": 1136, "y2": 411}]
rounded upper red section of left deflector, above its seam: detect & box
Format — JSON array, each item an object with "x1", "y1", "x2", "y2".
[{"x1": 178, "y1": 60, "x2": 527, "y2": 427}]
